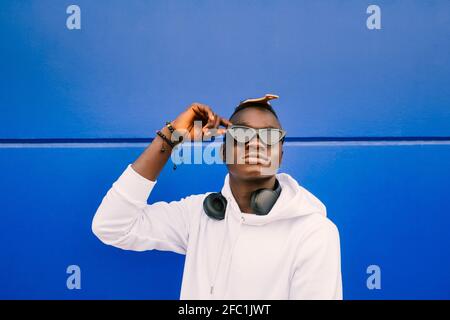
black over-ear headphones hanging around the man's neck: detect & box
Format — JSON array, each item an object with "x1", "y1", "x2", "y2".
[{"x1": 203, "y1": 180, "x2": 281, "y2": 220}]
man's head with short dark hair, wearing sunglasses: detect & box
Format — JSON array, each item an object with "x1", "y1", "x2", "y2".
[{"x1": 223, "y1": 95, "x2": 284, "y2": 180}]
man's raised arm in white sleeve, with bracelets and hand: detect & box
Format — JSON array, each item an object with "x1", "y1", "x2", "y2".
[{"x1": 92, "y1": 103, "x2": 229, "y2": 254}]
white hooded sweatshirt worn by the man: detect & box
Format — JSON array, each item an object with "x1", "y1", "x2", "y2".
[{"x1": 92, "y1": 165, "x2": 342, "y2": 299}]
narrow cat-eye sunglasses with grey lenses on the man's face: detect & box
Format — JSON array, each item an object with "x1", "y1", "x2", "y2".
[{"x1": 227, "y1": 125, "x2": 286, "y2": 146}]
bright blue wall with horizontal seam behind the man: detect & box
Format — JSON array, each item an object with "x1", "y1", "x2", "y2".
[{"x1": 0, "y1": 0, "x2": 450, "y2": 299}]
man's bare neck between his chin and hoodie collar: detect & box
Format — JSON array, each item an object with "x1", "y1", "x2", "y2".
[{"x1": 229, "y1": 174, "x2": 276, "y2": 213}]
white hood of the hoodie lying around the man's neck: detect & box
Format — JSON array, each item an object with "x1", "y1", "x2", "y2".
[{"x1": 222, "y1": 173, "x2": 326, "y2": 225}]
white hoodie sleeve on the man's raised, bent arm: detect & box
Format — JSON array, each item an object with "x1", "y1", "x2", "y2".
[{"x1": 92, "y1": 164, "x2": 191, "y2": 254}]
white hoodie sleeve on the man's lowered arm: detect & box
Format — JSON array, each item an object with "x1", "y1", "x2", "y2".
[{"x1": 289, "y1": 218, "x2": 342, "y2": 300}]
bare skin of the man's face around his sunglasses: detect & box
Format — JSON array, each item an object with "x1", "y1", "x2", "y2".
[{"x1": 223, "y1": 107, "x2": 283, "y2": 180}]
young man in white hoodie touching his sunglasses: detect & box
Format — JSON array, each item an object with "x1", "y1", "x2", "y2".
[{"x1": 92, "y1": 95, "x2": 342, "y2": 299}]
